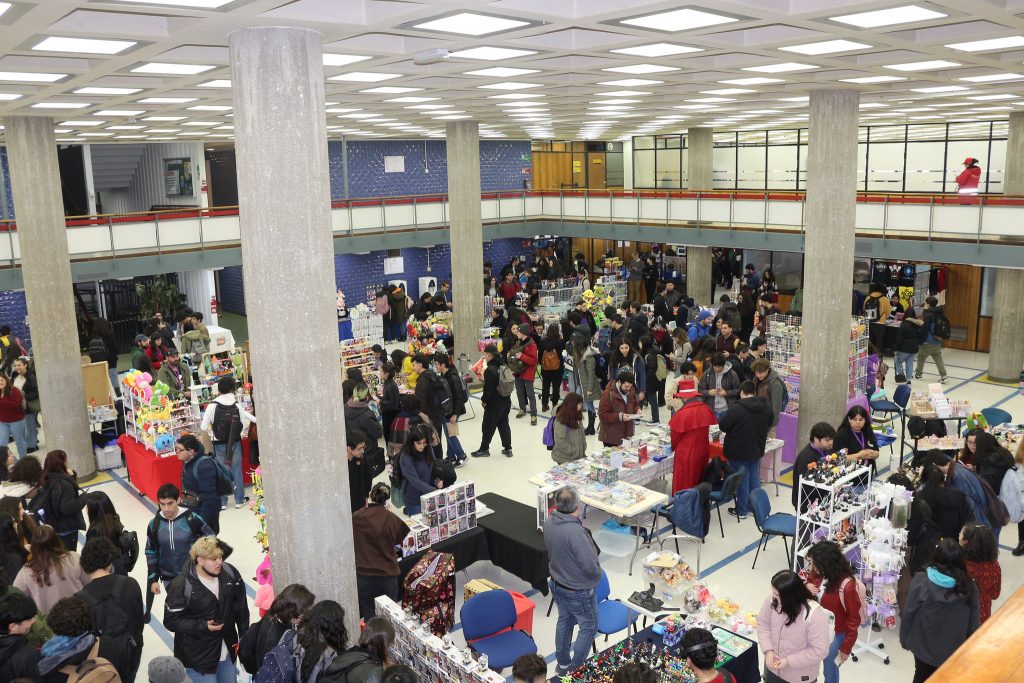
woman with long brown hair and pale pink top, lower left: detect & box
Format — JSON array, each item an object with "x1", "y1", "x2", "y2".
[{"x1": 14, "y1": 524, "x2": 89, "y2": 614}]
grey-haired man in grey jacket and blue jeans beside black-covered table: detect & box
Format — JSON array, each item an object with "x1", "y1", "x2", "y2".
[{"x1": 544, "y1": 486, "x2": 601, "y2": 676}]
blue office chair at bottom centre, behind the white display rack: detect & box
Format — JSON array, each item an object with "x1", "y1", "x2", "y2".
[{"x1": 459, "y1": 591, "x2": 537, "y2": 672}]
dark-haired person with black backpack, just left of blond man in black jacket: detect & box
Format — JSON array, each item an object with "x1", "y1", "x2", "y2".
[{"x1": 78, "y1": 537, "x2": 144, "y2": 683}]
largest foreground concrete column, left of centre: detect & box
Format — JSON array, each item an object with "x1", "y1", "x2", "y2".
[{"x1": 228, "y1": 27, "x2": 359, "y2": 634}]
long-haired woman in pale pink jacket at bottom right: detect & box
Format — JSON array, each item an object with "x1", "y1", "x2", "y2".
[{"x1": 758, "y1": 569, "x2": 831, "y2": 683}]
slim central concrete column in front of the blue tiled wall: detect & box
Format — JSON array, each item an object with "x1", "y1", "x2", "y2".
[{"x1": 445, "y1": 121, "x2": 483, "y2": 368}]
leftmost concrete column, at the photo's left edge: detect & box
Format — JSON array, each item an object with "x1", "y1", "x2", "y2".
[{"x1": 4, "y1": 117, "x2": 96, "y2": 479}]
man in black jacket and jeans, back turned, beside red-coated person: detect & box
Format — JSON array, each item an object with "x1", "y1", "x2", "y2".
[{"x1": 718, "y1": 381, "x2": 772, "y2": 519}]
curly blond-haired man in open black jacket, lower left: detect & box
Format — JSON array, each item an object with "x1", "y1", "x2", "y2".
[{"x1": 164, "y1": 536, "x2": 249, "y2": 682}]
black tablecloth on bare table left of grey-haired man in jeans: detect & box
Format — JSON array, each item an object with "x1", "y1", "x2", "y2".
[{"x1": 477, "y1": 494, "x2": 550, "y2": 595}]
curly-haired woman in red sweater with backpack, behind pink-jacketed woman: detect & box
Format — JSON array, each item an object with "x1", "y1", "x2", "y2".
[{"x1": 807, "y1": 541, "x2": 867, "y2": 683}]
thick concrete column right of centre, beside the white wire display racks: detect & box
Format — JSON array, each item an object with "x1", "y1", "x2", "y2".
[{"x1": 798, "y1": 90, "x2": 860, "y2": 439}]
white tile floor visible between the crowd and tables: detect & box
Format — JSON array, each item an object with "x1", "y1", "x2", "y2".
[{"x1": 81, "y1": 350, "x2": 1024, "y2": 682}]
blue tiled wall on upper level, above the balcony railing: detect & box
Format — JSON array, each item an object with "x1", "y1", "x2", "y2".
[{"x1": 328, "y1": 140, "x2": 531, "y2": 199}]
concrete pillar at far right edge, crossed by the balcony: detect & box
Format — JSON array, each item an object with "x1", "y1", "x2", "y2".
[{"x1": 988, "y1": 112, "x2": 1024, "y2": 382}]
